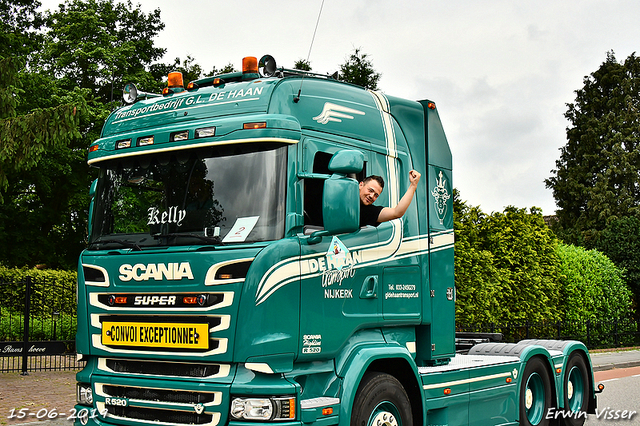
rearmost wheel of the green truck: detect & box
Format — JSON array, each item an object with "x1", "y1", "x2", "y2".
[{"x1": 562, "y1": 353, "x2": 590, "y2": 426}]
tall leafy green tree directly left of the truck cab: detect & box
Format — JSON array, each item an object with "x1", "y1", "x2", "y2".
[{"x1": 0, "y1": 0, "x2": 164, "y2": 268}]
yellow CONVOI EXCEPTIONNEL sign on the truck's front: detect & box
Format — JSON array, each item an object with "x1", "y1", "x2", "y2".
[{"x1": 102, "y1": 321, "x2": 209, "y2": 349}]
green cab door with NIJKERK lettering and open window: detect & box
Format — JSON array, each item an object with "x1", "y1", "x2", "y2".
[{"x1": 299, "y1": 139, "x2": 382, "y2": 360}]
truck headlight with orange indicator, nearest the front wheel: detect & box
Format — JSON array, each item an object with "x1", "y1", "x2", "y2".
[{"x1": 231, "y1": 397, "x2": 296, "y2": 421}]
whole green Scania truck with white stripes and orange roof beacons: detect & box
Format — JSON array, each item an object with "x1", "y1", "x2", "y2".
[{"x1": 75, "y1": 56, "x2": 597, "y2": 426}]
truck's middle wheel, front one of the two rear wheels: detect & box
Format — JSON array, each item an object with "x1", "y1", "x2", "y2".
[{"x1": 519, "y1": 358, "x2": 552, "y2": 426}]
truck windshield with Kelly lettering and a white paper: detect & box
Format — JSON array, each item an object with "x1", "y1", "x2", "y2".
[{"x1": 89, "y1": 144, "x2": 287, "y2": 249}]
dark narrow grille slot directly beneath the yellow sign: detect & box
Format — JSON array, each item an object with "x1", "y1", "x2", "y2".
[{"x1": 106, "y1": 359, "x2": 220, "y2": 377}]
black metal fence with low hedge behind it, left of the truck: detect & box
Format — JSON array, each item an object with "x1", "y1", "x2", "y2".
[{"x1": 0, "y1": 276, "x2": 83, "y2": 375}]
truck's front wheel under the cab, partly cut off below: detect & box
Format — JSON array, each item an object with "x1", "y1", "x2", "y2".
[{"x1": 351, "y1": 372, "x2": 413, "y2": 426}]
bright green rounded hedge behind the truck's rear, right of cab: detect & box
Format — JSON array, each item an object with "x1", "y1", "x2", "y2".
[{"x1": 454, "y1": 199, "x2": 633, "y2": 324}]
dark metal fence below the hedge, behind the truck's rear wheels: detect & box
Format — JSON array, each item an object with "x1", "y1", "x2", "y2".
[{"x1": 456, "y1": 317, "x2": 640, "y2": 349}]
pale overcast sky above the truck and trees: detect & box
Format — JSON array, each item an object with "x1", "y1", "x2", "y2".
[{"x1": 42, "y1": 0, "x2": 640, "y2": 214}]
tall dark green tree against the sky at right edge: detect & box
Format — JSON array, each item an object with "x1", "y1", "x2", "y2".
[{"x1": 545, "y1": 52, "x2": 640, "y2": 240}]
